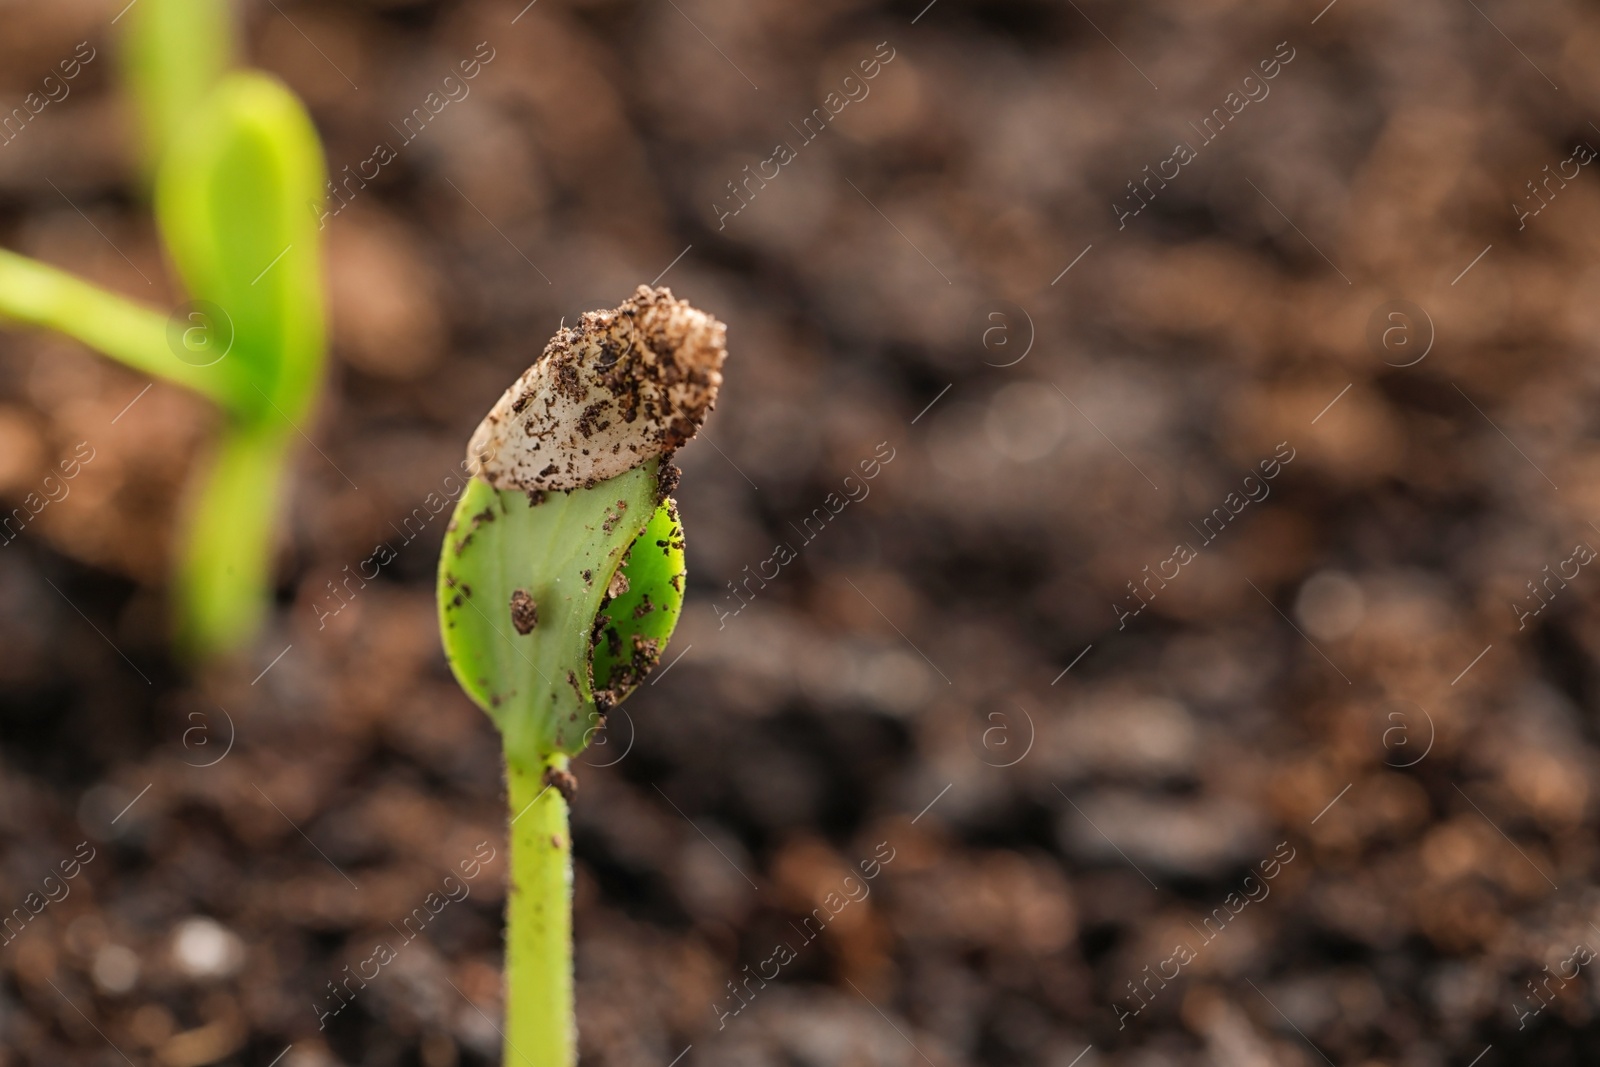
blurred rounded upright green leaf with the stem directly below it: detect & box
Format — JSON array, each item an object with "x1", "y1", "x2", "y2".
[{"x1": 155, "y1": 72, "x2": 326, "y2": 654}]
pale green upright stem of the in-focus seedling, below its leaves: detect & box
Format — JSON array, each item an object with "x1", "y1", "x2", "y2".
[{"x1": 502, "y1": 757, "x2": 578, "y2": 1067}]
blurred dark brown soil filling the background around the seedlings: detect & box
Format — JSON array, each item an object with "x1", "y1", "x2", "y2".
[{"x1": 0, "y1": 0, "x2": 1600, "y2": 1067}]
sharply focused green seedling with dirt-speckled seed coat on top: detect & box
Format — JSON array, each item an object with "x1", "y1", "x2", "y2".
[{"x1": 438, "y1": 286, "x2": 725, "y2": 1067}]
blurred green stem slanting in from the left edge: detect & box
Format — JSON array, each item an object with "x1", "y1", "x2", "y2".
[{"x1": 0, "y1": 250, "x2": 238, "y2": 410}]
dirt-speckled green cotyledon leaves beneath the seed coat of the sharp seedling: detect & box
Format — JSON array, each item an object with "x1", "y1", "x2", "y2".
[{"x1": 438, "y1": 459, "x2": 683, "y2": 768}]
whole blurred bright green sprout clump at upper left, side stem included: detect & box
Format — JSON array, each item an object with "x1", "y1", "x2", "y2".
[{"x1": 0, "y1": 0, "x2": 326, "y2": 656}]
